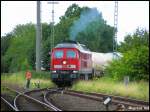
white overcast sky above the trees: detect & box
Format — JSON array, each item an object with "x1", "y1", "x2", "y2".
[{"x1": 1, "y1": 1, "x2": 149, "y2": 42}]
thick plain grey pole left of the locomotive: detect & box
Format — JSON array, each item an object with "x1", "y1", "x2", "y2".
[{"x1": 36, "y1": 1, "x2": 41, "y2": 71}]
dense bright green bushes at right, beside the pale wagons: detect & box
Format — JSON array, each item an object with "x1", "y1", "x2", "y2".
[{"x1": 106, "y1": 29, "x2": 149, "y2": 81}]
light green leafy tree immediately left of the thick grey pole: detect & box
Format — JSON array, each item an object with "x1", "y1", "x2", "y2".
[{"x1": 4, "y1": 23, "x2": 35, "y2": 72}]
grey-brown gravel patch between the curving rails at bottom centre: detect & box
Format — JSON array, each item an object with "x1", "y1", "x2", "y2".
[{"x1": 46, "y1": 90, "x2": 116, "y2": 111}]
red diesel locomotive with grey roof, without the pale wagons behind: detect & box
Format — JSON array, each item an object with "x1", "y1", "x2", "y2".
[{"x1": 51, "y1": 41, "x2": 92, "y2": 85}]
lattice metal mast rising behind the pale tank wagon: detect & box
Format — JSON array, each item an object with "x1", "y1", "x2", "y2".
[{"x1": 113, "y1": 1, "x2": 118, "y2": 59}]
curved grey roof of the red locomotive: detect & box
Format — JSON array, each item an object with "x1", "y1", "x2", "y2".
[{"x1": 55, "y1": 42, "x2": 90, "y2": 53}]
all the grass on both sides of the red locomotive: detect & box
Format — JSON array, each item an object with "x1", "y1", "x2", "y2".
[{"x1": 1, "y1": 71, "x2": 149, "y2": 101}]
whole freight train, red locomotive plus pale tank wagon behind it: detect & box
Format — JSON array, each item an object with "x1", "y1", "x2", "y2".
[{"x1": 50, "y1": 40, "x2": 122, "y2": 85}]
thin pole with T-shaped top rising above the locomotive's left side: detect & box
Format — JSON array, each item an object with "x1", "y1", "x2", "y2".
[{"x1": 48, "y1": 1, "x2": 58, "y2": 52}]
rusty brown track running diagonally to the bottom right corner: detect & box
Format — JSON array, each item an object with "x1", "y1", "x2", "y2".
[{"x1": 64, "y1": 90, "x2": 149, "y2": 110}]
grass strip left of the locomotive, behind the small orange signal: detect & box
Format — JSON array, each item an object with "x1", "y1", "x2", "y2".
[{"x1": 1, "y1": 71, "x2": 55, "y2": 89}]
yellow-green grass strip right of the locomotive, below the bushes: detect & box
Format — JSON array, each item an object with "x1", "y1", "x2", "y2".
[{"x1": 72, "y1": 77, "x2": 149, "y2": 101}]
